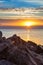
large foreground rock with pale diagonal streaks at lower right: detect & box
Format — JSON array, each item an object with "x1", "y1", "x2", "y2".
[{"x1": 7, "y1": 44, "x2": 43, "y2": 65}]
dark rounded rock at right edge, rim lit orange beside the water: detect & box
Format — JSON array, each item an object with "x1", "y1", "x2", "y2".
[{"x1": 26, "y1": 41, "x2": 43, "y2": 54}]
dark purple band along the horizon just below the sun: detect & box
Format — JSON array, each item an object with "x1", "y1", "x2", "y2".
[{"x1": 0, "y1": 26, "x2": 43, "y2": 29}]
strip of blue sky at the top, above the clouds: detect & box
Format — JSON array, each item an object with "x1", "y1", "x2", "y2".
[{"x1": 0, "y1": 0, "x2": 43, "y2": 8}]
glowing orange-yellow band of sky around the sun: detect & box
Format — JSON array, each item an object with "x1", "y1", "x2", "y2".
[{"x1": 0, "y1": 18, "x2": 43, "y2": 26}]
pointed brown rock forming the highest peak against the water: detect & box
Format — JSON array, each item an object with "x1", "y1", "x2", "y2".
[{"x1": 8, "y1": 34, "x2": 26, "y2": 46}]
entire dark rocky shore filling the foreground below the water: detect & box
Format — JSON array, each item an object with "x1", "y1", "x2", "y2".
[{"x1": 0, "y1": 31, "x2": 43, "y2": 65}]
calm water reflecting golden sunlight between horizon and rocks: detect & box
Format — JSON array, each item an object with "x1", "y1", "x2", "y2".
[{"x1": 0, "y1": 29, "x2": 43, "y2": 45}]
